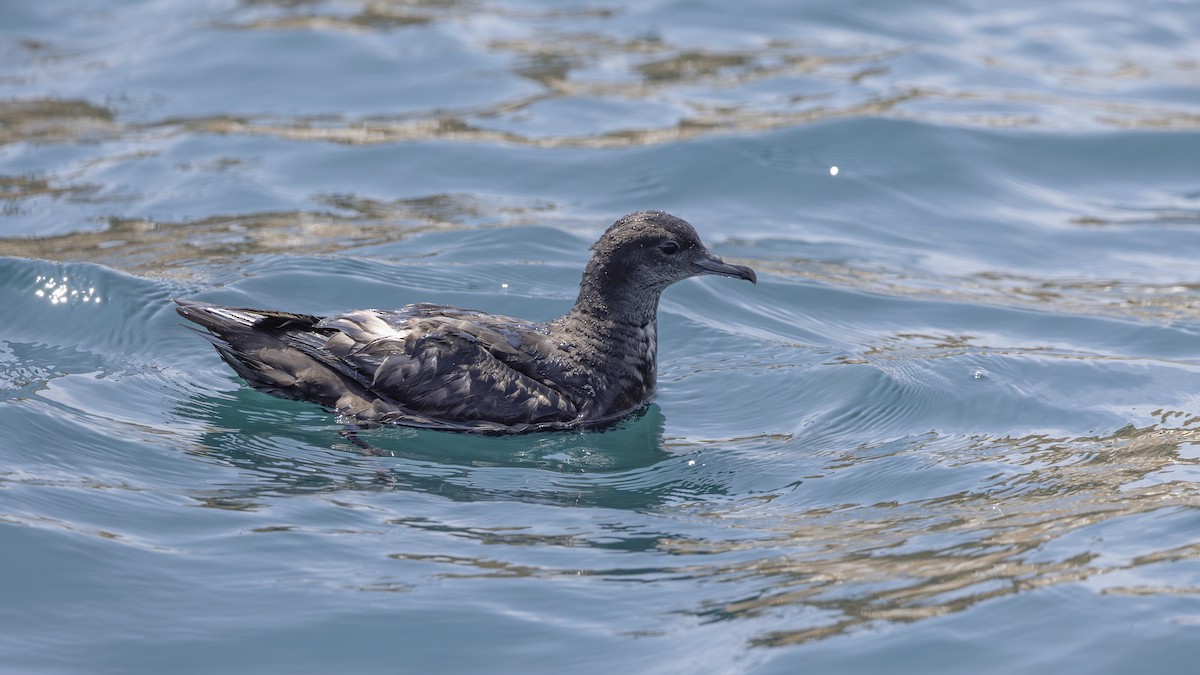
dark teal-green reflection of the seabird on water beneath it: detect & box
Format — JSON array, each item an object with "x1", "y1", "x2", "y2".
[{"x1": 188, "y1": 389, "x2": 686, "y2": 508}]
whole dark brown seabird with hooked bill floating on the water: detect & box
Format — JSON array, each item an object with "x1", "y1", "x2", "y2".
[{"x1": 175, "y1": 211, "x2": 757, "y2": 434}]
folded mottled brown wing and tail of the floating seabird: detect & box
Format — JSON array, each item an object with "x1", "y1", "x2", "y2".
[{"x1": 179, "y1": 297, "x2": 577, "y2": 428}]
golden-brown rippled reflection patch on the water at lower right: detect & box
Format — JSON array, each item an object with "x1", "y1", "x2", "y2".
[{"x1": 664, "y1": 416, "x2": 1200, "y2": 645}]
